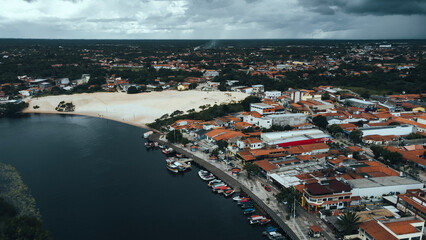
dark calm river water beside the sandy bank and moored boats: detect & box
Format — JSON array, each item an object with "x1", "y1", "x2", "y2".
[{"x1": 0, "y1": 115, "x2": 266, "y2": 240}]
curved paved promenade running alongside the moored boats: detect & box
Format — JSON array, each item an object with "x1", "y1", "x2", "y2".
[{"x1": 149, "y1": 133, "x2": 299, "y2": 240}]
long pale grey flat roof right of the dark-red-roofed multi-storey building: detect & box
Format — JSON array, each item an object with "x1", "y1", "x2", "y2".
[{"x1": 348, "y1": 176, "x2": 422, "y2": 188}]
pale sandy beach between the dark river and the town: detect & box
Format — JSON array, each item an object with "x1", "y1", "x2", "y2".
[{"x1": 24, "y1": 91, "x2": 248, "y2": 127}]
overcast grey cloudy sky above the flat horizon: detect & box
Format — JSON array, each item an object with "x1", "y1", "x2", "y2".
[{"x1": 0, "y1": 0, "x2": 426, "y2": 39}]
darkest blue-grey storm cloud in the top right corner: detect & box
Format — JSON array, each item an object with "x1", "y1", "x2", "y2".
[{"x1": 299, "y1": 0, "x2": 426, "y2": 16}]
